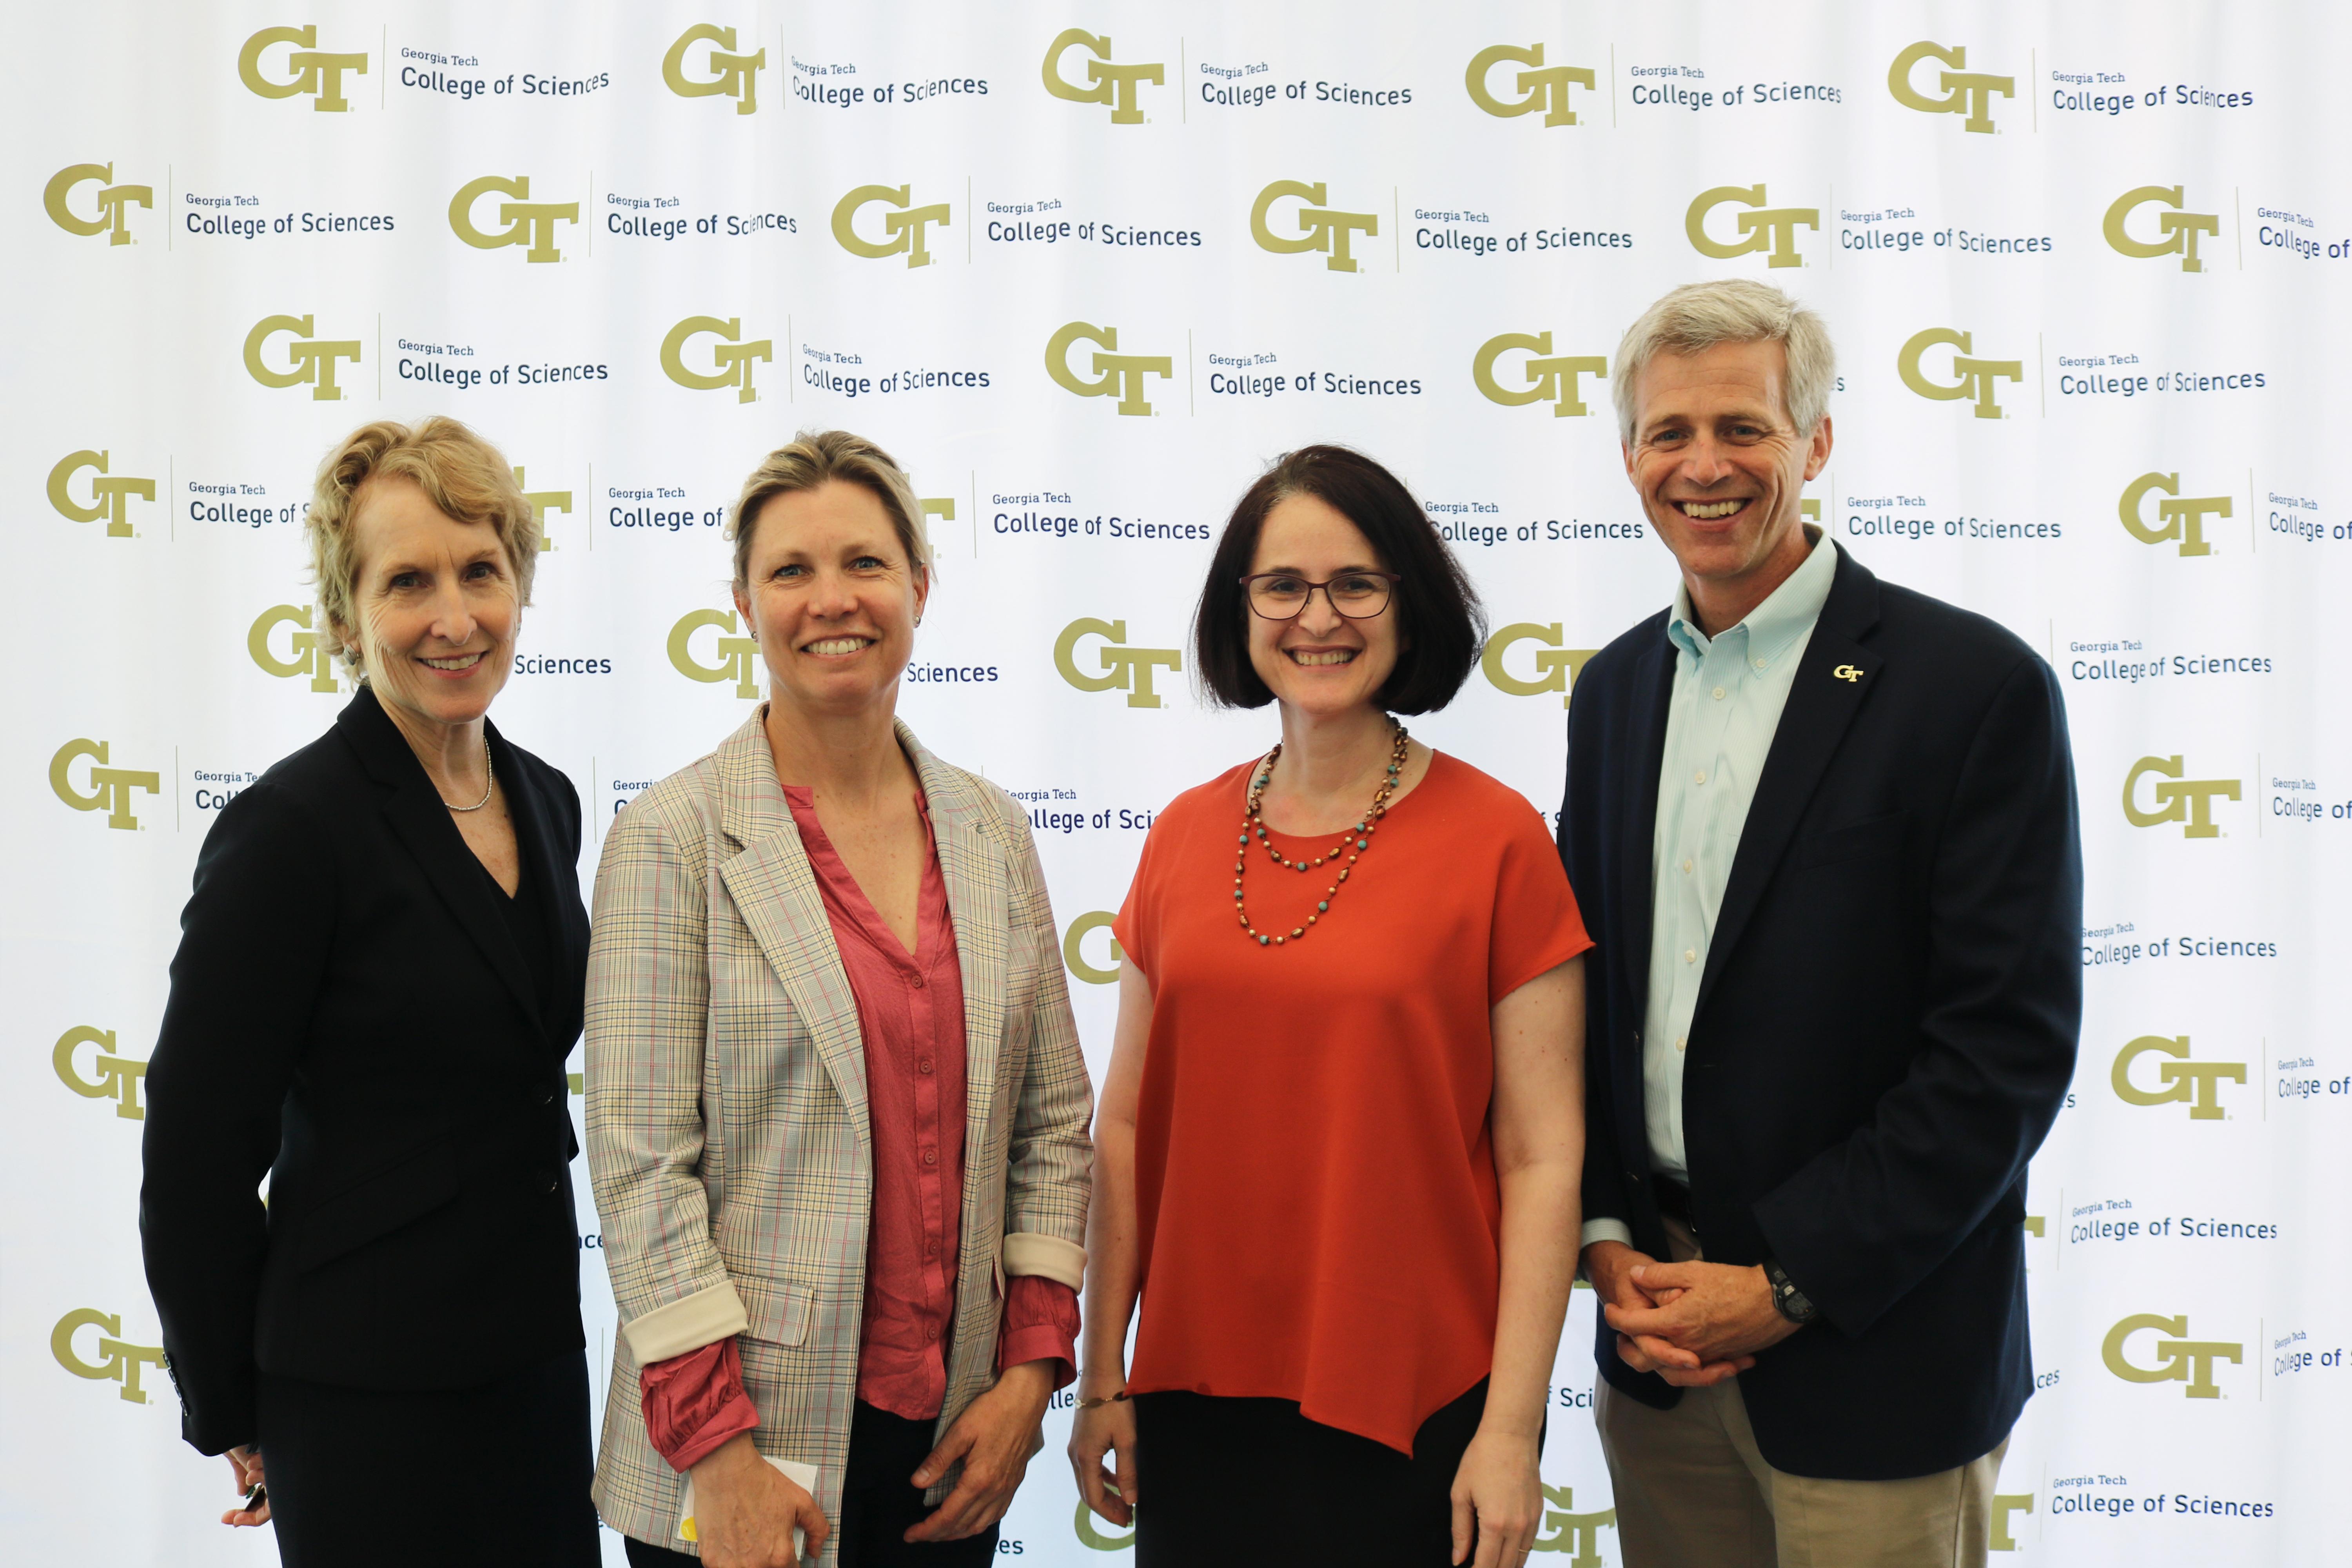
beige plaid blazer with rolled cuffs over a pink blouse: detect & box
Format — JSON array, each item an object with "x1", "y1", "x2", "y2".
[{"x1": 586, "y1": 705, "x2": 1094, "y2": 1563}]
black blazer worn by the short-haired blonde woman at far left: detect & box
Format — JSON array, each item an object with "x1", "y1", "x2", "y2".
[{"x1": 139, "y1": 686, "x2": 588, "y2": 1453}]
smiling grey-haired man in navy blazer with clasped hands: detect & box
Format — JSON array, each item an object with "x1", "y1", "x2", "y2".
[{"x1": 1559, "y1": 280, "x2": 2082, "y2": 1568}]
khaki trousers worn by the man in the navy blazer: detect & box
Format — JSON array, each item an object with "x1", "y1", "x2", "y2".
[{"x1": 1592, "y1": 1220, "x2": 2009, "y2": 1568}]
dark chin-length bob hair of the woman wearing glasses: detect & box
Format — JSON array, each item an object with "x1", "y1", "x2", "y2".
[{"x1": 1192, "y1": 446, "x2": 1486, "y2": 712}]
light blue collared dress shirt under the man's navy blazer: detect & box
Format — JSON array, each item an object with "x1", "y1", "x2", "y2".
[{"x1": 1583, "y1": 529, "x2": 1837, "y2": 1246}]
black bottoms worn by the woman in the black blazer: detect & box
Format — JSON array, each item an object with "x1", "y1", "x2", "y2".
[{"x1": 256, "y1": 1349, "x2": 602, "y2": 1568}]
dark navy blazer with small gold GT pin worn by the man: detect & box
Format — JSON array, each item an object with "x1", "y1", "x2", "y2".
[{"x1": 1559, "y1": 541, "x2": 2082, "y2": 1481}]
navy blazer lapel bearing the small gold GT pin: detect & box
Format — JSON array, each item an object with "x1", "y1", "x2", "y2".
[{"x1": 1693, "y1": 550, "x2": 1886, "y2": 1023}]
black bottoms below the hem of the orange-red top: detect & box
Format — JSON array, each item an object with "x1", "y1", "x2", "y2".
[{"x1": 1136, "y1": 1377, "x2": 1486, "y2": 1568}]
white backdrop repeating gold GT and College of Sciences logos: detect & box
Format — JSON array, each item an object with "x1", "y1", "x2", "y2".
[{"x1": 0, "y1": 0, "x2": 2352, "y2": 1566}]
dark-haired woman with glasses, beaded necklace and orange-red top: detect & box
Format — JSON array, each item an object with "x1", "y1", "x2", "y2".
[{"x1": 1070, "y1": 446, "x2": 1592, "y2": 1568}]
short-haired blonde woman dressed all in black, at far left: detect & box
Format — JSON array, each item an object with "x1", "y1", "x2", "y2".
[{"x1": 139, "y1": 418, "x2": 597, "y2": 1568}]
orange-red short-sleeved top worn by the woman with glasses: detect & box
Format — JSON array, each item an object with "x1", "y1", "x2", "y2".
[{"x1": 1112, "y1": 755, "x2": 1592, "y2": 1453}]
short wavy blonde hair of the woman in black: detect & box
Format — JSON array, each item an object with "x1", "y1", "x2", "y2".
[{"x1": 303, "y1": 414, "x2": 539, "y2": 679}]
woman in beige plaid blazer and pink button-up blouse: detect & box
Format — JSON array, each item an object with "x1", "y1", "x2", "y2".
[{"x1": 586, "y1": 432, "x2": 1091, "y2": 1568}]
